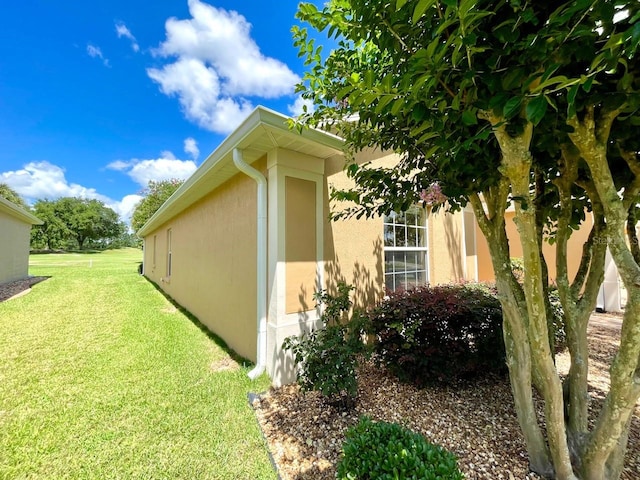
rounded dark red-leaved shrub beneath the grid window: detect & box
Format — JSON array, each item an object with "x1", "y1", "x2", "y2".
[{"x1": 369, "y1": 284, "x2": 506, "y2": 385}]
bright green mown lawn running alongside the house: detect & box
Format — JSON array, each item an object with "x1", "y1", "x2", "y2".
[{"x1": 0, "y1": 249, "x2": 276, "y2": 480}]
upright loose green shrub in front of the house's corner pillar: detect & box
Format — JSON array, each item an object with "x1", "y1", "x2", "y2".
[{"x1": 282, "y1": 283, "x2": 365, "y2": 406}]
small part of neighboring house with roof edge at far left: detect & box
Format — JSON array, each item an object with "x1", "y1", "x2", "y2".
[{"x1": 0, "y1": 197, "x2": 42, "y2": 284}]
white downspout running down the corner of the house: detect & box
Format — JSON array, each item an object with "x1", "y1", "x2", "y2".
[{"x1": 233, "y1": 148, "x2": 267, "y2": 380}]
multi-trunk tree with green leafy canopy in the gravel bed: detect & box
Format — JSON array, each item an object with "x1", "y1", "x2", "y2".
[{"x1": 293, "y1": 0, "x2": 640, "y2": 480}]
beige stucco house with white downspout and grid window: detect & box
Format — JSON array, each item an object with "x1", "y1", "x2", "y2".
[{"x1": 138, "y1": 107, "x2": 608, "y2": 385}]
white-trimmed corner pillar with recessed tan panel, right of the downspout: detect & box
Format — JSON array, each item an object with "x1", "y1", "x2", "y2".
[{"x1": 267, "y1": 148, "x2": 324, "y2": 385}]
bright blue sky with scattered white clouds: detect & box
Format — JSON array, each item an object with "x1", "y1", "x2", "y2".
[{"x1": 0, "y1": 0, "x2": 320, "y2": 223}]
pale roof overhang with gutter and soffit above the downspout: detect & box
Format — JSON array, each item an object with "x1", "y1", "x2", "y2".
[{"x1": 138, "y1": 106, "x2": 344, "y2": 237}]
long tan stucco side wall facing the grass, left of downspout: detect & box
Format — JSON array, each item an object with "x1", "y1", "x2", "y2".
[{"x1": 144, "y1": 158, "x2": 266, "y2": 361}]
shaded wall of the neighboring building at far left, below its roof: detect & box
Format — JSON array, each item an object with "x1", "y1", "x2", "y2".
[{"x1": 0, "y1": 211, "x2": 31, "y2": 283}]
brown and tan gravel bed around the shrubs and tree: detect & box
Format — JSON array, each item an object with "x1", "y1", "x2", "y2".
[{"x1": 253, "y1": 317, "x2": 640, "y2": 480}]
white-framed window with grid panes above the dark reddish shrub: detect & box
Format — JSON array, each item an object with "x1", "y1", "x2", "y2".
[{"x1": 384, "y1": 206, "x2": 429, "y2": 290}]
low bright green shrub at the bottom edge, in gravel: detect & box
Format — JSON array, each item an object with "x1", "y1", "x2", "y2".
[{"x1": 336, "y1": 417, "x2": 464, "y2": 480}]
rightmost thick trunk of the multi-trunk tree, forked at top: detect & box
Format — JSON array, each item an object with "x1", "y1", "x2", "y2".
[{"x1": 569, "y1": 106, "x2": 640, "y2": 480}]
